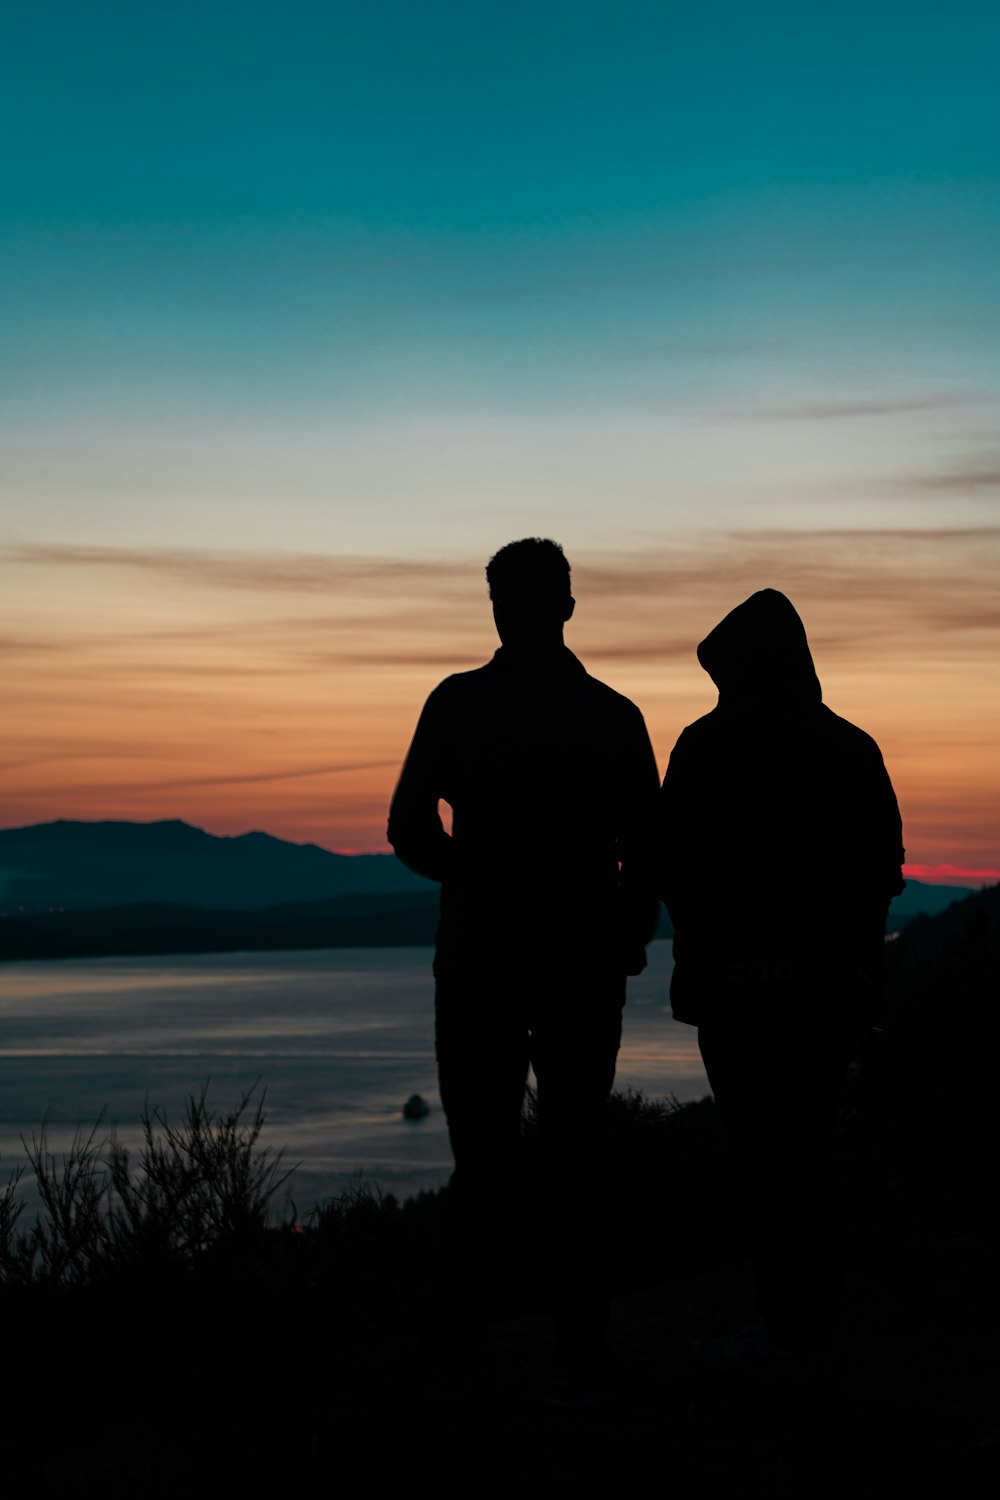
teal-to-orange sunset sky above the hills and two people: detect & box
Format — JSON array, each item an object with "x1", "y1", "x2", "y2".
[{"x1": 0, "y1": 0, "x2": 1000, "y2": 881}]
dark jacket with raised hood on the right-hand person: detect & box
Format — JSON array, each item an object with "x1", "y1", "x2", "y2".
[{"x1": 657, "y1": 590, "x2": 904, "y2": 1023}]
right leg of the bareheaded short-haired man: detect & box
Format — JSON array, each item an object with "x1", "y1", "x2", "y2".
[{"x1": 531, "y1": 977, "x2": 625, "y2": 1362}]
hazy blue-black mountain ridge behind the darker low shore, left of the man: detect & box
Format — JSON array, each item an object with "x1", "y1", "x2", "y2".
[{"x1": 0, "y1": 819, "x2": 436, "y2": 914}]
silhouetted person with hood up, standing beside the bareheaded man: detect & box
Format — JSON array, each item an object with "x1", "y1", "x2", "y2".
[{"x1": 658, "y1": 588, "x2": 904, "y2": 1368}]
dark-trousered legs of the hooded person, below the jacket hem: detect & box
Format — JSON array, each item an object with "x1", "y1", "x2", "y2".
[{"x1": 699, "y1": 1013, "x2": 856, "y2": 1346}]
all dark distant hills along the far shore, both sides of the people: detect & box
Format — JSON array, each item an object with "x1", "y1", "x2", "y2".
[{"x1": 0, "y1": 821, "x2": 969, "y2": 960}]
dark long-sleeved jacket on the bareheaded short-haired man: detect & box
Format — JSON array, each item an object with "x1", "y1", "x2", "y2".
[{"x1": 388, "y1": 645, "x2": 660, "y2": 975}]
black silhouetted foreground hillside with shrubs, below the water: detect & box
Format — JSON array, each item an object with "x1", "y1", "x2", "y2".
[{"x1": 0, "y1": 890, "x2": 1000, "y2": 1500}]
